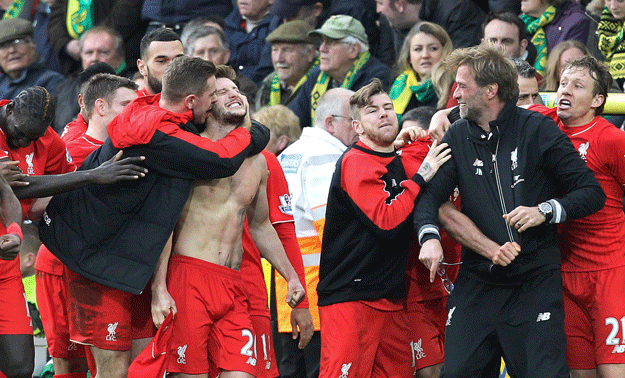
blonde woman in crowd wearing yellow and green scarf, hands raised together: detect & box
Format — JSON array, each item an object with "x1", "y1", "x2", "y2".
[{"x1": 390, "y1": 22, "x2": 453, "y2": 117}]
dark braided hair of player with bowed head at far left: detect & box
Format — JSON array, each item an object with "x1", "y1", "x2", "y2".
[{"x1": 13, "y1": 86, "x2": 56, "y2": 130}]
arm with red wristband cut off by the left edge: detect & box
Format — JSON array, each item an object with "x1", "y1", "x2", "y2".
[{"x1": 0, "y1": 175, "x2": 22, "y2": 260}]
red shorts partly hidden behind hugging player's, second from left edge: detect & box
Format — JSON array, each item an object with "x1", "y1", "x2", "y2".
[{"x1": 35, "y1": 271, "x2": 85, "y2": 358}]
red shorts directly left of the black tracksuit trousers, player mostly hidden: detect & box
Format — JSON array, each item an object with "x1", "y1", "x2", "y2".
[{"x1": 406, "y1": 297, "x2": 447, "y2": 370}]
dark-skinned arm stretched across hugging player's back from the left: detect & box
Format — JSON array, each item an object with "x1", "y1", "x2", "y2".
[{"x1": 13, "y1": 151, "x2": 147, "y2": 199}]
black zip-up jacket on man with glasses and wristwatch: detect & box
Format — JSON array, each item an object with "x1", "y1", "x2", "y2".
[{"x1": 414, "y1": 98, "x2": 605, "y2": 283}]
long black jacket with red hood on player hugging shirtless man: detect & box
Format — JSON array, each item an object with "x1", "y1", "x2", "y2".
[{"x1": 39, "y1": 95, "x2": 269, "y2": 294}]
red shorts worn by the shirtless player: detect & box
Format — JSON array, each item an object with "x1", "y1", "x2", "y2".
[{"x1": 167, "y1": 255, "x2": 257, "y2": 376}]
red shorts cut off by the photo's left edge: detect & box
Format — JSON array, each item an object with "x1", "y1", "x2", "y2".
[{"x1": 0, "y1": 257, "x2": 33, "y2": 335}]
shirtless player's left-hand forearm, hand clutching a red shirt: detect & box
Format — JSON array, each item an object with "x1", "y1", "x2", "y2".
[{"x1": 151, "y1": 234, "x2": 178, "y2": 328}]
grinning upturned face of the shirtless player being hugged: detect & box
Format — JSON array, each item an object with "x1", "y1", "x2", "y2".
[{"x1": 213, "y1": 77, "x2": 248, "y2": 126}]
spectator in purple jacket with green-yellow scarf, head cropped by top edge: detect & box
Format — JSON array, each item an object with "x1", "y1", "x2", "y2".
[{"x1": 521, "y1": 0, "x2": 590, "y2": 75}]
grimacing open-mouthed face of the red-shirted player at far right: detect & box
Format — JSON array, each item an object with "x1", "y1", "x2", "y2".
[{"x1": 556, "y1": 67, "x2": 605, "y2": 126}]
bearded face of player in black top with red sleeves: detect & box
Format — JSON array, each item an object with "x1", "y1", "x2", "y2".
[{"x1": 353, "y1": 93, "x2": 399, "y2": 150}]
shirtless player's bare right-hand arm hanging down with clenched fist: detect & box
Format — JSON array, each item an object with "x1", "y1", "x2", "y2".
[{"x1": 247, "y1": 158, "x2": 306, "y2": 307}]
